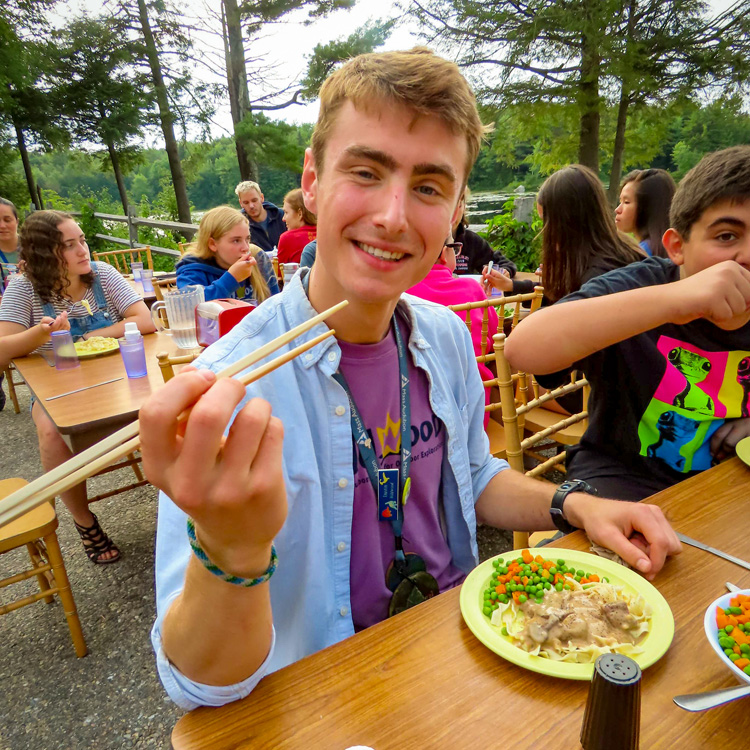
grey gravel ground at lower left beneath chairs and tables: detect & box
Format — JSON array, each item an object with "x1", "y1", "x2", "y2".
[{"x1": 0, "y1": 387, "x2": 511, "y2": 750}]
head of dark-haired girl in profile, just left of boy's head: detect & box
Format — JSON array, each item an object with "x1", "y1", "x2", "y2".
[{"x1": 615, "y1": 169, "x2": 677, "y2": 258}]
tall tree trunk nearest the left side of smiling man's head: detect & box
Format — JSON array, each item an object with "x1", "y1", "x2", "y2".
[{"x1": 222, "y1": 0, "x2": 258, "y2": 181}]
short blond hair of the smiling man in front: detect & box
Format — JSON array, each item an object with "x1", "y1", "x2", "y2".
[{"x1": 311, "y1": 47, "x2": 488, "y2": 188}]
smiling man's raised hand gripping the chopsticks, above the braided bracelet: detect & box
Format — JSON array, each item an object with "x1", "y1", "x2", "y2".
[{"x1": 140, "y1": 367, "x2": 287, "y2": 578}]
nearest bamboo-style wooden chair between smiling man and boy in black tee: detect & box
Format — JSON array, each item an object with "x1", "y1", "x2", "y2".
[{"x1": 495, "y1": 333, "x2": 590, "y2": 549}]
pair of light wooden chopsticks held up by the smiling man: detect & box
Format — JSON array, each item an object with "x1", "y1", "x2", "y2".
[{"x1": 0, "y1": 300, "x2": 349, "y2": 526}]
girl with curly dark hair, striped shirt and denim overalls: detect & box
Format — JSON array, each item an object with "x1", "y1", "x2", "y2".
[{"x1": 0, "y1": 211, "x2": 154, "y2": 564}]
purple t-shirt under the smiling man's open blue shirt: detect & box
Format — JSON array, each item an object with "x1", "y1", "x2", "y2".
[{"x1": 339, "y1": 320, "x2": 465, "y2": 631}]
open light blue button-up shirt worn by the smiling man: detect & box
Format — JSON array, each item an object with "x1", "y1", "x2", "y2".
[{"x1": 151, "y1": 269, "x2": 508, "y2": 709}]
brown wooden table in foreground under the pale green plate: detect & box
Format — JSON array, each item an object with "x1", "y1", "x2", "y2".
[{"x1": 172, "y1": 458, "x2": 750, "y2": 750}]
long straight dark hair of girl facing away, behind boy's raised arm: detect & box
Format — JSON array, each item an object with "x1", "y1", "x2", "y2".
[{"x1": 482, "y1": 164, "x2": 645, "y2": 302}]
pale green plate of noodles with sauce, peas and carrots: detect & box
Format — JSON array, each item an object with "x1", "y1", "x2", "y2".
[{"x1": 460, "y1": 548, "x2": 674, "y2": 680}]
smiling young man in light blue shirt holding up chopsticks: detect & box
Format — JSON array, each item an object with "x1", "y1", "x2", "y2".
[{"x1": 141, "y1": 49, "x2": 680, "y2": 708}]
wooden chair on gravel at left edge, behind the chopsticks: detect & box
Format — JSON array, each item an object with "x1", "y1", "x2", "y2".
[{"x1": 0, "y1": 479, "x2": 88, "y2": 657}]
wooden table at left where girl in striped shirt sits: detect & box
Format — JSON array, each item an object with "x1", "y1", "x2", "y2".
[{"x1": 13, "y1": 332, "x2": 186, "y2": 453}]
